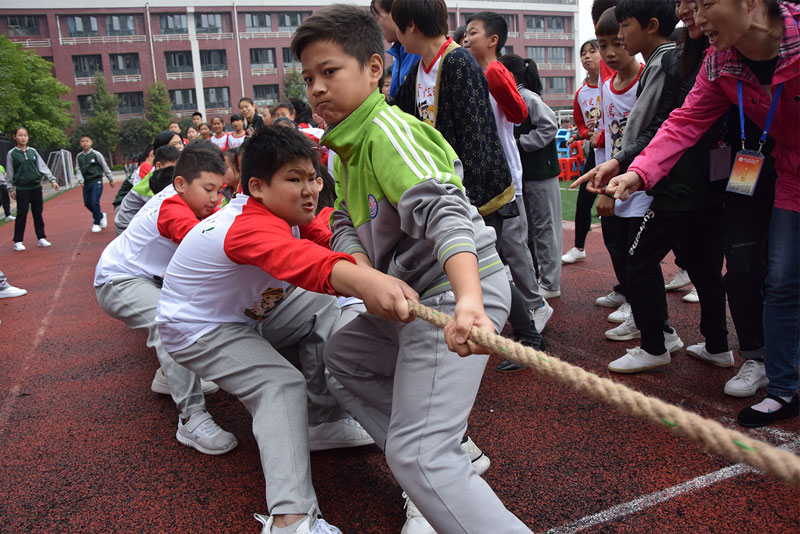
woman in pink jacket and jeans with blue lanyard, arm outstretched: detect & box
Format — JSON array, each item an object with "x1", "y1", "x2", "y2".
[{"x1": 608, "y1": 0, "x2": 800, "y2": 427}]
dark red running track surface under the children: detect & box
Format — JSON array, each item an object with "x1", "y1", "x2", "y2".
[{"x1": 0, "y1": 190, "x2": 800, "y2": 534}]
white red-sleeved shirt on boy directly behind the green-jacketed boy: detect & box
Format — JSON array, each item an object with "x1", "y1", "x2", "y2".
[{"x1": 156, "y1": 194, "x2": 355, "y2": 352}]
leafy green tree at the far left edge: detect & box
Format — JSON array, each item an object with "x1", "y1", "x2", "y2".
[{"x1": 0, "y1": 35, "x2": 74, "y2": 148}]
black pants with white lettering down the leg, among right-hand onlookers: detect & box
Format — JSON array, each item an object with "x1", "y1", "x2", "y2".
[{"x1": 627, "y1": 207, "x2": 728, "y2": 354}]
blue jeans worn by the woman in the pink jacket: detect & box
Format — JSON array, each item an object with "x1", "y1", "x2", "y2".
[{"x1": 764, "y1": 208, "x2": 800, "y2": 397}]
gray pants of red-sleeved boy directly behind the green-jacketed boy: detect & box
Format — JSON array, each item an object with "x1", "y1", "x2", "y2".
[{"x1": 172, "y1": 288, "x2": 347, "y2": 515}]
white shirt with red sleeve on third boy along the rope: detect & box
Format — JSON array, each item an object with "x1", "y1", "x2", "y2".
[{"x1": 94, "y1": 185, "x2": 198, "y2": 287}]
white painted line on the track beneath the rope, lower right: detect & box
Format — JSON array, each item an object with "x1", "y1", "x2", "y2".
[{"x1": 546, "y1": 427, "x2": 800, "y2": 534}]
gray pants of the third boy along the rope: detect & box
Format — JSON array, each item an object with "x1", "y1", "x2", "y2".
[{"x1": 95, "y1": 277, "x2": 206, "y2": 418}]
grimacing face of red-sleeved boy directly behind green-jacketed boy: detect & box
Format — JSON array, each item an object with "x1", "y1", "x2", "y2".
[{"x1": 248, "y1": 158, "x2": 322, "y2": 226}]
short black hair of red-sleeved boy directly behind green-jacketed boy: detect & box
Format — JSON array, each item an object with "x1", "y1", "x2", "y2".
[{"x1": 241, "y1": 126, "x2": 318, "y2": 195}]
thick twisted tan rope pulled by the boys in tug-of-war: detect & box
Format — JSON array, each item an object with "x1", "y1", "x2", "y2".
[{"x1": 408, "y1": 301, "x2": 800, "y2": 489}]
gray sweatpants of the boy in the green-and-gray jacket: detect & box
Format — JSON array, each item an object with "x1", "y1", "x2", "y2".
[{"x1": 325, "y1": 271, "x2": 530, "y2": 534}]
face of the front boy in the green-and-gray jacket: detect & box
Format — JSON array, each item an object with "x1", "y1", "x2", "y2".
[{"x1": 300, "y1": 41, "x2": 383, "y2": 126}]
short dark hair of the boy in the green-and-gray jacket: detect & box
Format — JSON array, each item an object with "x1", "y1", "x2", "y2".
[{"x1": 292, "y1": 4, "x2": 383, "y2": 66}]
